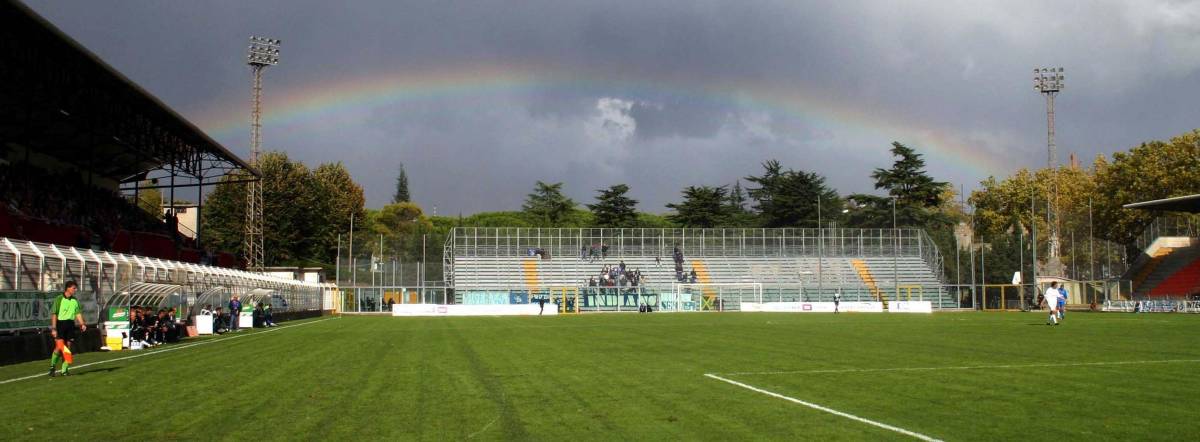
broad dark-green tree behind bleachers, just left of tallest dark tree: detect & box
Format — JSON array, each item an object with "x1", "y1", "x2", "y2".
[{"x1": 746, "y1": 160, "x2": 842, "y2": 227}]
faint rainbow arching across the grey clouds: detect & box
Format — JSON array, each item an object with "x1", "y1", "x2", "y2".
[{"x1": 197, "y1": 64, "x2": 1012, "y2": 177}]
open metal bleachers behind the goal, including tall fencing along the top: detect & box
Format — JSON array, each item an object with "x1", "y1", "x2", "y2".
[{"x1": 444, "y1": 227, "x2": 959, "y2": 310}]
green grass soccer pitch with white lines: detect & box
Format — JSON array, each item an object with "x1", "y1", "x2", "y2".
[{"x1": 0, "y1": 312, "x2": 1200, "y2": 440}]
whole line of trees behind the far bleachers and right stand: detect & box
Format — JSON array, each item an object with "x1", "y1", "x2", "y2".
[{"x1": 202, "y1": 131, "x2": 1200, "y2": 281}]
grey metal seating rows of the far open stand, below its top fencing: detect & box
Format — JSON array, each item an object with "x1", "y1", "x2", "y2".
[{"x1": 448, "y1": 229, "x2": 956, "y2": 307}]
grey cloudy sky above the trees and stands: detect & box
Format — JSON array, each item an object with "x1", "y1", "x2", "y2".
[{"x1": 21, "y1": 0, "x2": 1200, "y2": 214}]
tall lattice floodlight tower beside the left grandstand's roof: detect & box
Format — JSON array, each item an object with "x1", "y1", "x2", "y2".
[{"x1": 244, "y1": 36, "x2": 280, "y2": 271}]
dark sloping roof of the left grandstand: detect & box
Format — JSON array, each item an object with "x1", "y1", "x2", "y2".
[{"x1": 0, "y1": 0, "x2": 260, "y2": 183}]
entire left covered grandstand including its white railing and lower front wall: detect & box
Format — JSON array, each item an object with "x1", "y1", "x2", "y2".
[{"x1": 0, "y1": 0, "x2": 331, "y2": 363}]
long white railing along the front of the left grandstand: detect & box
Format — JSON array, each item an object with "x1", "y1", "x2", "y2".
[{"x1": 0, "y1": 238, "x2": 332, "y2": 323}]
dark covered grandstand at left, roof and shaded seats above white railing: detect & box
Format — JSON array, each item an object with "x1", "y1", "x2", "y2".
[{"x1": 0, "y1": 1, "x2": 259, "y2": 267}]
